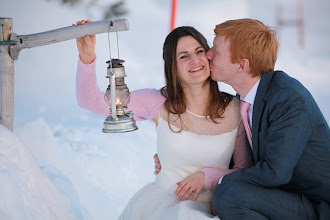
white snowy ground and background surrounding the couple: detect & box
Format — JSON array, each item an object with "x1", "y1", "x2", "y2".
[{"x1": 0, "y1": 0, "x2": 330, "y2": 219}]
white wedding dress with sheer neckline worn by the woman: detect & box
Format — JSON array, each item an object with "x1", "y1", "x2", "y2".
[{"x1": 119, "y1": 99, "x2": 240, "y2": 220}]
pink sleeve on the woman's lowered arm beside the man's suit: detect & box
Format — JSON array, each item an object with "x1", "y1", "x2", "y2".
[{"x1": 200, "y1": 125, "x2": 250, "y2": 190}]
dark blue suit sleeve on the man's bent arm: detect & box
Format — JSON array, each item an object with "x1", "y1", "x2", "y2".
[{"x1": 222, "y1": 89, "x2": 312, "y2": 187}]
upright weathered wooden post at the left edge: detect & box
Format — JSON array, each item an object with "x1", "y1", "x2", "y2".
[{"x1": 0, "y1": 18, "x2": 14, "y2": 131}]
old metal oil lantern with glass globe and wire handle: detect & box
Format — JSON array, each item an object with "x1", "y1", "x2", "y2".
[{"x1": 102, "y1": 21, "x2": 138, "y2": 133}]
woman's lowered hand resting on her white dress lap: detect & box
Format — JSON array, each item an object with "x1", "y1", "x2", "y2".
[{"x1": 174, "y1": 171, "x2": 206, "y2": 201}]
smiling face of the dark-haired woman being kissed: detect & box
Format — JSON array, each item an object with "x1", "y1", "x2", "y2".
[{"x1": 176, "y1": 36, "x2": 210, "y2": 86}]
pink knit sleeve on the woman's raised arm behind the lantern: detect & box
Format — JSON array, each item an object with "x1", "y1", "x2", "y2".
[{"x1": 76, "y1": 56, "x2": 165, "y2": 120}]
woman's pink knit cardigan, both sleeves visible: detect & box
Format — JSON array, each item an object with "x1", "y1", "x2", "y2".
[{"x1": 76, "y1": 59, "x2": 249, "y2": 190}]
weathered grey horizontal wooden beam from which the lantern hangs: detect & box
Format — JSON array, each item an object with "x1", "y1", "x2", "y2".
[{"x1": 10, "y1": 19, "x2": 129, "y2": 60}]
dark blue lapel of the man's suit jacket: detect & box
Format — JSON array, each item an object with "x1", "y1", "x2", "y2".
[{"x1": 251, "y1": 71, "x2": 274, "y2": 163}]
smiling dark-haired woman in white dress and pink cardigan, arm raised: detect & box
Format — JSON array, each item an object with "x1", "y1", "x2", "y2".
[{"x1": 77, "y1": 20, "x2": 248, "y2": 220}]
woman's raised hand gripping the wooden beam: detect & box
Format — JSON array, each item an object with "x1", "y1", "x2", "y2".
[{"x1": 73, "y1": 19, "x2": 96, "y2": 64}]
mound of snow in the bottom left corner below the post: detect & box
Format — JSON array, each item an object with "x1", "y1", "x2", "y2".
[{"x1": 0, "y1": 125, "x2": 77, "y2": 220}]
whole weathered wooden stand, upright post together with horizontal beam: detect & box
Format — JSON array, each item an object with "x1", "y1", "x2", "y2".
[{"x1": 0, "y1": 17, "x2": 129, "y2": 131}]
